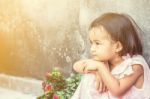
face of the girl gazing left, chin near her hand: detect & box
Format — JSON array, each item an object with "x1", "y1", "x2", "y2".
[{"x1": 89, "y1": 26, "x2": 116, "y2": 61}]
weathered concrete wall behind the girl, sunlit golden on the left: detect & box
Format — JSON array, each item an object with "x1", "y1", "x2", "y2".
[{"x1": 0, "y1": 0, "x2": 150, "y2": 97}]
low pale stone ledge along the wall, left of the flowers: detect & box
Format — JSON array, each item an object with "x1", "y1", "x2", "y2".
[{"x1": 0, "y1": 74, "x2": 43, "y2": 96}]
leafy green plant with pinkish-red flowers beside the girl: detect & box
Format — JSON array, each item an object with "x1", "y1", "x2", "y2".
[{"x1": 37, "y1": 69, "x2": 81, "y2": 99}]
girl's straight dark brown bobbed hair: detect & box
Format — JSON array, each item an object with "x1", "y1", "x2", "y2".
[{"x1": 90, "y1": 13, "x2": 143, "y2": 56}]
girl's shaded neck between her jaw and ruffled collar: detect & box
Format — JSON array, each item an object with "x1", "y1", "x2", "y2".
[{"x1": 109, "y1": 56, "x2": 123, "y2": 71}]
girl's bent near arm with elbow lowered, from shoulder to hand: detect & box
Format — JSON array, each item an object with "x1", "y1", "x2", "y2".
[{"x1": 86, "y1": 61, "x2": 143, "y2": 96}]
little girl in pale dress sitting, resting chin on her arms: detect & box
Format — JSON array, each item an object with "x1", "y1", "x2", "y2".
[{"x1": 71, "y1": 13, "x2": 150, "y2": 99}]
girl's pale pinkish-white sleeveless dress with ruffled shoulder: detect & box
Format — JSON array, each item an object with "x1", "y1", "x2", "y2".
[{"x1": 71, "y1": 55, "x2": 150, "y2": 99}]
